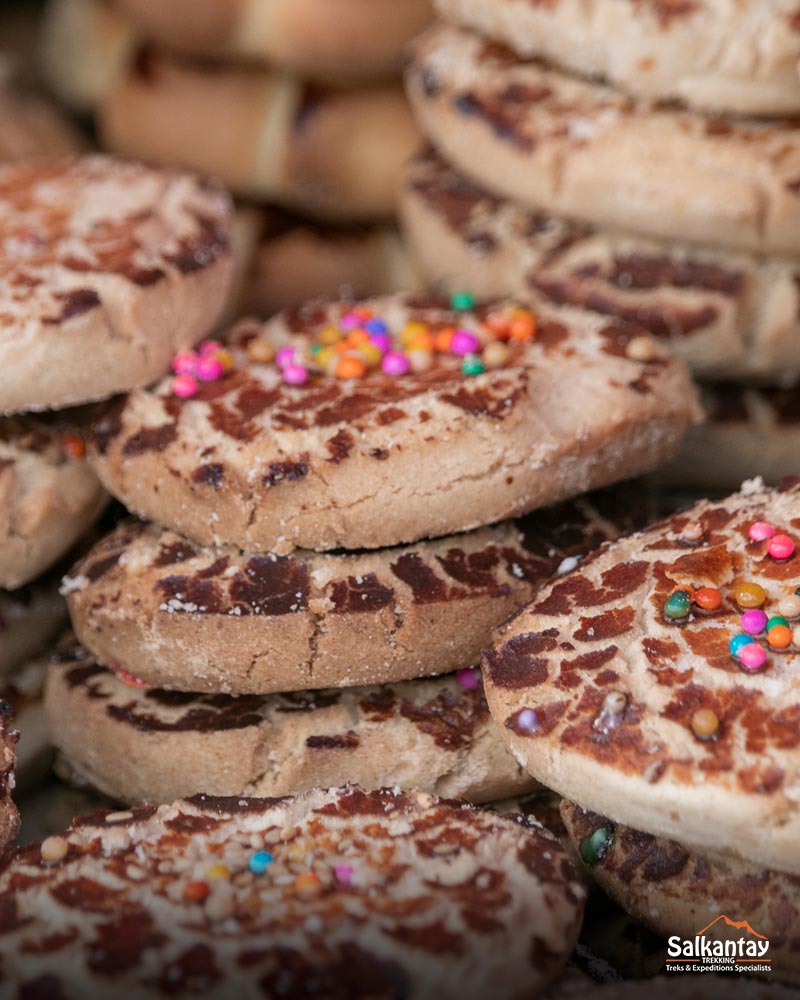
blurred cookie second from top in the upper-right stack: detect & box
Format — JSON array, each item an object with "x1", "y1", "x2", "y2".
[{"x1": 407, "y1": 26, "x2": 800, "y2": 255}]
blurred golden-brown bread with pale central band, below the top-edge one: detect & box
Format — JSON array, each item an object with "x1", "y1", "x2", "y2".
[{"x1": 100, "y1": 53, "x2": 419, "y2": 221}]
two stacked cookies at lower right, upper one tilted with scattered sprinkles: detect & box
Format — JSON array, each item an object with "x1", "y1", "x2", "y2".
[{"x1": 484, "y1": 477, "x2": 800, "y2": 982}]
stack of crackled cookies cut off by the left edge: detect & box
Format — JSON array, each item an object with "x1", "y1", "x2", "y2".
[{"x1": 0, "y1": 156, "x2": 231, "y2": 796}]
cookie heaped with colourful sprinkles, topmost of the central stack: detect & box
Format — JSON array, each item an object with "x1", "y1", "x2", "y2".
[{"x1": 91, "y1": 296, "x2": 697, "y2": 553}]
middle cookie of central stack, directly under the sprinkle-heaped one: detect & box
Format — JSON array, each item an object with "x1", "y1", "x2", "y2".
[{"x1": 63, "y1": 490, "x2": 646, "y2": 692}]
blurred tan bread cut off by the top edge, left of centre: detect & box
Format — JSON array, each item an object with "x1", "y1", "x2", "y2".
[{"x1": 114, "y1": 0, "x2": 432, "y2": 82}]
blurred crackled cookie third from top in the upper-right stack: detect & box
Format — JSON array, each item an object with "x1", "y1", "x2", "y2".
[{"x1": 400, "y1": 150, "x2": 800, "y2": 384}]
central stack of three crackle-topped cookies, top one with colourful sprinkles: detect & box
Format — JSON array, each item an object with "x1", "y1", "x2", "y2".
[{"x1": 46, "y1": 294, "x2": 696, "y2": 802}]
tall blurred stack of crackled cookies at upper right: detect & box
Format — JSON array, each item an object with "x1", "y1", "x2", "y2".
[{"x1": 402, "y1": 0, "x2": 800, "y2": 490}]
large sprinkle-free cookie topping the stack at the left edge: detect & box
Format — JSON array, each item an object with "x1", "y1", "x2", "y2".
[{"x1": 0, "y1": 156, "x2": 231, "y2": 413}]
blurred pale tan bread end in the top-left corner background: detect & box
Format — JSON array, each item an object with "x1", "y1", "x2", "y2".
[{"x1": 38, "y1": 0, "x2": 137, "y2": 114}]
